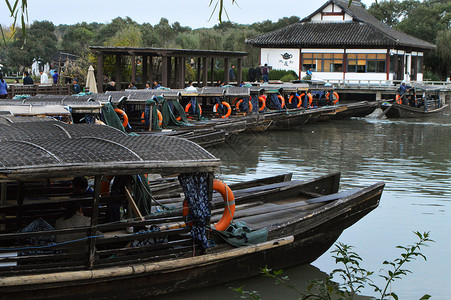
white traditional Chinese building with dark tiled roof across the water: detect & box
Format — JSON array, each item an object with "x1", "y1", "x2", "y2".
[{"x1": 246, "y1": 0, "x2": 435, "y2": 81}]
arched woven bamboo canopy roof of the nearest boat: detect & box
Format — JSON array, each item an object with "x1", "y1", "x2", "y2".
[{"x1": 0, "y1": 122, "x2": 220, "y2": 181}]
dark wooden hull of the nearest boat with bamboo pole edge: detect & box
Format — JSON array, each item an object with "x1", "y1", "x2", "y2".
[{"x1": 0, "y1": 178, "x2": 384, "y2": 299}]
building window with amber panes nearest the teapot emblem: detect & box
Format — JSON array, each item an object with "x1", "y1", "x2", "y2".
[{"x1": 302, "y1": 53, "x2": 343, "y2": 72}]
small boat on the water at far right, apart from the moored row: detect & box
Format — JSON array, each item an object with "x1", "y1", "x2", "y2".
[{"x1": 380, "y1": 86, "x2": 448, "y2": 119}]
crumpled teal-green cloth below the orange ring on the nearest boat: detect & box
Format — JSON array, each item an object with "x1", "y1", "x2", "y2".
[{"x1": 213, "y1": 221, "x2": 268, "y2": 247}]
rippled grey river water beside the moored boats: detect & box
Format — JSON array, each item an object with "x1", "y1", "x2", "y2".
[{"x1": 161, "y1": 109, "x2": 451, "y2": 299}]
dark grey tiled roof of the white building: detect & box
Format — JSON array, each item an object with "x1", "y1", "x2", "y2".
[{"x1": 246, "y1": 0, "x2": 435, "y2": 49}]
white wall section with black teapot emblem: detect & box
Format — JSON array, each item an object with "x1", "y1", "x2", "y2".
[{"x1": 260, "y1": 48, "x2": 300, "y2": 75}]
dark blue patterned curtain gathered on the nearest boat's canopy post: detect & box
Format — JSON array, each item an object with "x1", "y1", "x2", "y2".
[{"x1": 178, "y1": 173, "x2": 211, "y2": 249}]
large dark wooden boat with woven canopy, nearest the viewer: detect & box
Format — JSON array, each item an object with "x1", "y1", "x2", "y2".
[{"x1": 0, "y1": 122, "x2": 384, "y2": 299}]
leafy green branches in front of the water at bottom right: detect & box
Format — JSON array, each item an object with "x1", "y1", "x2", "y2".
[{"x1": 234, "y1": 232, "x2": 434, "y2": 300}]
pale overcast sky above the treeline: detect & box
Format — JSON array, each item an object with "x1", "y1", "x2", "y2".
[{"x1": 0, "y1": 0, "x2": 374, "y2": 29}]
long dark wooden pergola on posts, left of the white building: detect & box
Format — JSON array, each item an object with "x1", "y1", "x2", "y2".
[{"x1": 90, "y1": 46, "x2": 247, "y2": 91}]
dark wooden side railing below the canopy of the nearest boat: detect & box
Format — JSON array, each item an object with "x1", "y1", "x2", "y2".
[{"x1": 0, "y1": 216, "x2": 193, "y2": 276}]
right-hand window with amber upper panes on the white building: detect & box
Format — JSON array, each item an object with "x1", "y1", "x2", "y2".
[{"x1": 347, "y1": 53, "x2": 386, "y2": 73}]
